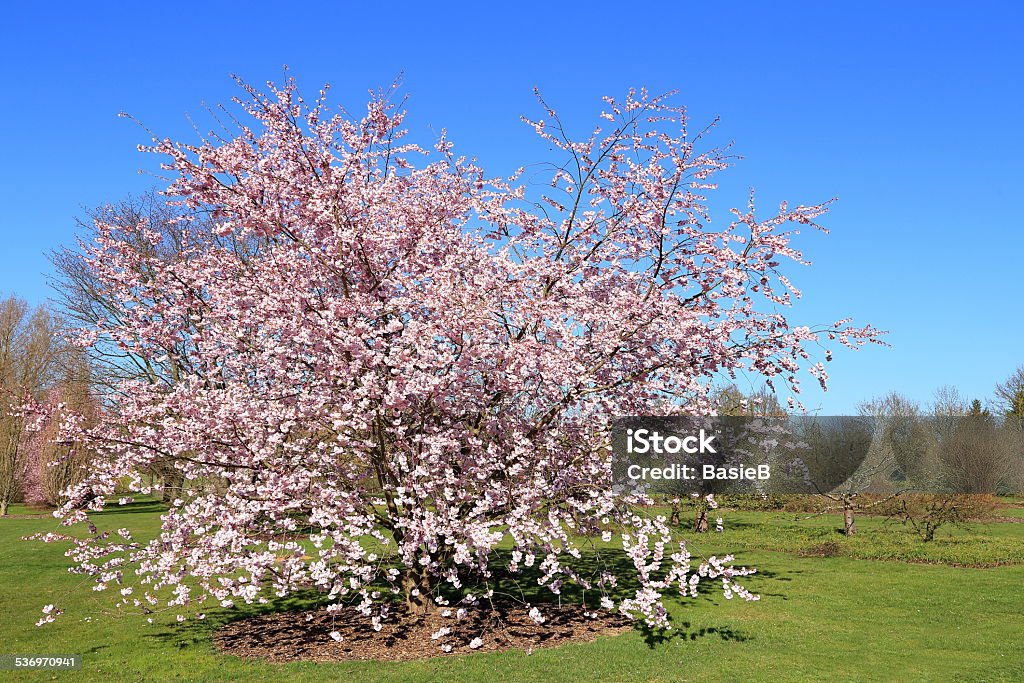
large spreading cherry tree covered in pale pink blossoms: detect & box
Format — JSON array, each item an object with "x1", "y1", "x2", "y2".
[{"x1": 41, "y1": 77, "x2": 876, "y2": 638}]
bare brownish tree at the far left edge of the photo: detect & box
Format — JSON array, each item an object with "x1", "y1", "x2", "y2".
[{"x1": 0, "y1": 296, "x2": 61, "y2": 515}]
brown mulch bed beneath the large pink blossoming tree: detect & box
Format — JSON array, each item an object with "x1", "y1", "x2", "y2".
[{"x1": 214, "y1": 605, "x2": 633, "y2": 661}]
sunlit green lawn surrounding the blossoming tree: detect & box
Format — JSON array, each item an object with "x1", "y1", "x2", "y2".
[{"x1": 0, "y1": 504, "x2": 1024, "y2": 683}]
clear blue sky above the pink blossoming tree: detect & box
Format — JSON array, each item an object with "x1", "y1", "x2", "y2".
[{"x1": 0, "y1": 1, "x2": 1024, "y2": 414}]
